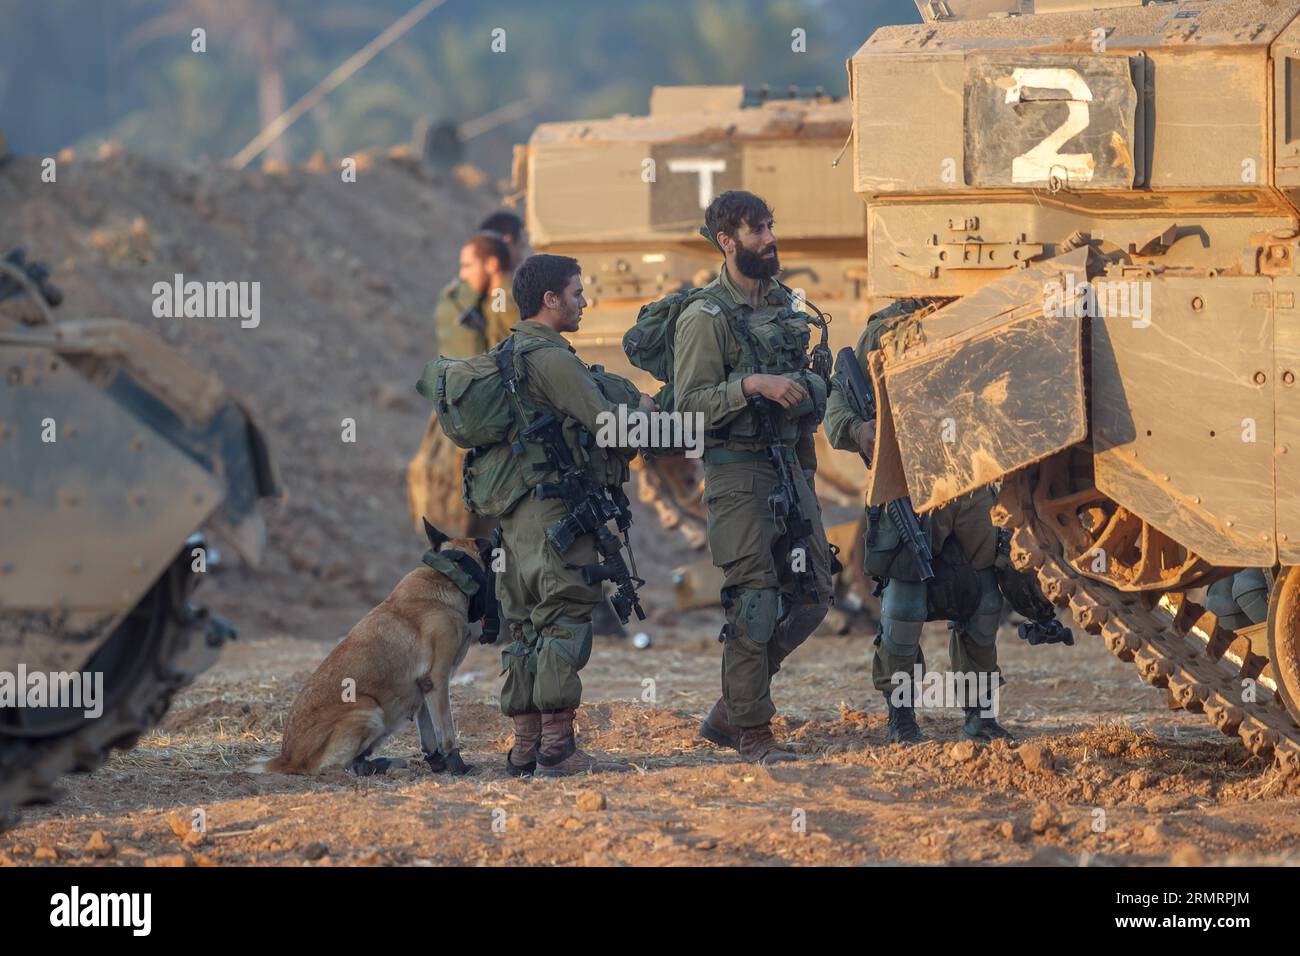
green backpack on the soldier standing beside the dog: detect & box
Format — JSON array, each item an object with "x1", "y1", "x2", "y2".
[{"x1": 415, "y1": 336, "x2": 551, "y2": 449}]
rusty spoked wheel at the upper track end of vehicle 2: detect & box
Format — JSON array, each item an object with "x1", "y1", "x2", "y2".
[{"x1": 1034, "y1": 449, "x2": 1214, "y2": 591}]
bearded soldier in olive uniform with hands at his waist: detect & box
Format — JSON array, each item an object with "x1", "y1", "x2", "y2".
[{"x1": 673, "y1": 191, "x2": 831, "y2": 763}]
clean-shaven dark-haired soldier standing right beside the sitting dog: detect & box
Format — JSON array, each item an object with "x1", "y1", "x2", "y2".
[{"x1": 465, "y1": 255, "x2": 657, "y2": 777}]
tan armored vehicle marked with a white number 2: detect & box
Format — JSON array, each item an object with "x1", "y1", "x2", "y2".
[{"x1": 849, "y1": 0, "x2": 1300, "y2": 767}]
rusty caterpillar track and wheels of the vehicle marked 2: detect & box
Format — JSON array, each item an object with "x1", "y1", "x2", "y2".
[{"x1": 991, "y1": 446, "x2": 1300, "y2": 770}]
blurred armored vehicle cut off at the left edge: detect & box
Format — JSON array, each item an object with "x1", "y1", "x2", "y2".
[{"x1": 0, "y1": 250, "x2": 276, "y2": 827}]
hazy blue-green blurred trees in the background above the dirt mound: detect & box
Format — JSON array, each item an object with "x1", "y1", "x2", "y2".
[{"x1": 0, "y1": 0, "x2": 919, "y2": 170}]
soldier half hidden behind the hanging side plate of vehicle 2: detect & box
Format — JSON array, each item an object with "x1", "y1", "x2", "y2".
[{"x1": 826, "y1": 300, "x2": 1011, "y2": 744}]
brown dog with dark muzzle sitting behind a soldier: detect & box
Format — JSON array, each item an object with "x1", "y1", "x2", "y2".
[{"x1": 250, "y1": 522, "x2": 495, "y2": 775}]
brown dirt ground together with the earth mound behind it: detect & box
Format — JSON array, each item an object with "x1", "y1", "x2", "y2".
[{"x1": 0, "y1": 150, "x2": 1300, "y2": 865}]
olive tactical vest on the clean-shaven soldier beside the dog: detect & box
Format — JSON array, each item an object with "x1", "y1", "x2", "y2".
[{"x1": 462, "y1": 336, "x2": 640, "y2": 518}]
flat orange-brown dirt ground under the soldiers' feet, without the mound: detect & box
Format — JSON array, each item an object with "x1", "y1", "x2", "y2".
[{"x1": 0, "y1": 541, "x2": 1300, "y2": 865}]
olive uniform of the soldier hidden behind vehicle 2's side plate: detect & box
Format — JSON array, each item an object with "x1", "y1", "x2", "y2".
[{"x1": 826, "y1": 302, "x2": 1005, "y2": 739}]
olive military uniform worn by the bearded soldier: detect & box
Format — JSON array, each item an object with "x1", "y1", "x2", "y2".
[{"x1": 673, "y1": 267, "x2": 831, "y2": 760}]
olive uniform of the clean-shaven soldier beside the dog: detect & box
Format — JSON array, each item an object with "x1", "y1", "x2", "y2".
[{"x1": 467, "y1": 320, "x2": 640, "y2": 764}]
